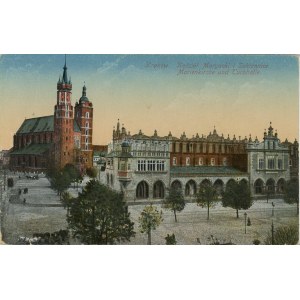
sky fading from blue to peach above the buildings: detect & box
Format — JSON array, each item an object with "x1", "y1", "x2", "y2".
[{"x1": 0, "y1": 54, "x2": 299, "y2": 148}]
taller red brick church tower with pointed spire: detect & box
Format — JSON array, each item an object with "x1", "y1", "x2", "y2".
[{"x1": 54, "y1": 57, "x2": 74, "y2": 168}]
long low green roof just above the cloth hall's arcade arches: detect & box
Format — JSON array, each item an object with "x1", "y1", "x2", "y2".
[{"x1": 170, "y1": 166, "x2": 247, "y2": 175}]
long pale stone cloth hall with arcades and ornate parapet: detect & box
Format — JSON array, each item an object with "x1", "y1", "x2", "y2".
[{"x1": 101, "y1": 121, "x2": 299, "y2": 201}]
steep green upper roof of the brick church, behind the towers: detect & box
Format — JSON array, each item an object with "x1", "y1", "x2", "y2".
[{"x1": 17, "y1": 116, "x2": 81, "y2": 134}]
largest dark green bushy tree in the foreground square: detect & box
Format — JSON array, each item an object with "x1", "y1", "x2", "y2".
[{"x1": 63, "y1": 180, "x2": 135, "y2": 245}]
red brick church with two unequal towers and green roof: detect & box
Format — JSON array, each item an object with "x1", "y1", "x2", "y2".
[{"x1": 10, "y1": 60, "x2": 93, "y2": 172}]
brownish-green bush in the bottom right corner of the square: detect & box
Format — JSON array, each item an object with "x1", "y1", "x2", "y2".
[{"x1": 265, "y1": 224, "x2": 299, "y2": 245}]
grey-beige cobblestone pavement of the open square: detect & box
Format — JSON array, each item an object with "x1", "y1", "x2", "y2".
[{"x1": 2, "y1": 172, "x2": 298, "y2": 245}]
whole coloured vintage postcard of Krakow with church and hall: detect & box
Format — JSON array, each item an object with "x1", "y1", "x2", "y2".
[{"x1": 0, "y1": 54, "x2": 299, "y2": 246}]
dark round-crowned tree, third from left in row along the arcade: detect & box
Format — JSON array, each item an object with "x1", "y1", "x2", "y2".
[{"x1": 222, "y1": 180, "x2": 253, "y2": 218}]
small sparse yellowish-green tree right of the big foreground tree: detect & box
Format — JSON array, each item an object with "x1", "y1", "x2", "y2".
[{"x1": 139, "y1": 204, "x2": 163, "y2": 245}]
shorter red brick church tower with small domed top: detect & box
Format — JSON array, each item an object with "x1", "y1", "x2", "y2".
[{"x1": 75, "y1": 84, "x2": 93, "y2": 169}]
